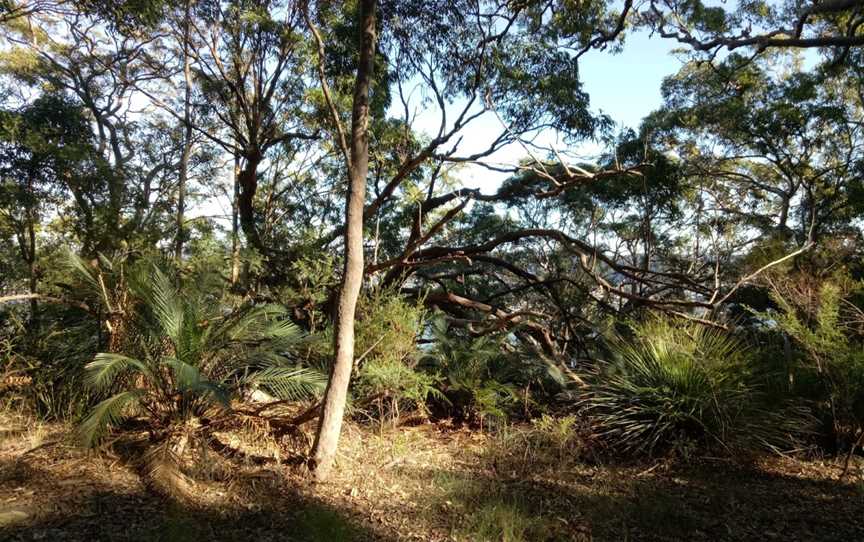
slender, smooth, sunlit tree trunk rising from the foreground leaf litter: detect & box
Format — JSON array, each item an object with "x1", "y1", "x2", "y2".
[{"x1": 309, "y1": 0, "x2": 377, "y2": 481}]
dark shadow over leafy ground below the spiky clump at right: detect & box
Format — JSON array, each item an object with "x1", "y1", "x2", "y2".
[{"x1": 394, "y1": 465, "x2": 864, "y2": 542}]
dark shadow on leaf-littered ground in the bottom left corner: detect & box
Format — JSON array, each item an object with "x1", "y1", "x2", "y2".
[{"x1": 0, "y1": 461, "x2": 391, "y2": 542}]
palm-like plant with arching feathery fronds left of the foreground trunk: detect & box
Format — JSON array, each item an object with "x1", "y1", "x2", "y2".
[{"x1": 80, "y1": 265, "x2": 325, "y2": 498}]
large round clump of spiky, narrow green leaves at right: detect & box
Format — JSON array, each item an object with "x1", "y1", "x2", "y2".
[{"x1": 580, "y1": 318, "x2": 808, "y2": 454}]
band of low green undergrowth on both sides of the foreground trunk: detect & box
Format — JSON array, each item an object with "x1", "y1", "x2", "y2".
[{"x1": 3, "y1": 254, "x2": 864, "y2": 472}]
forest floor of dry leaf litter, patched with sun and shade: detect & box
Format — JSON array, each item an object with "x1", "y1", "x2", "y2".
[{"x1": 0, "y1": 415, "x2": 864, "y2": 542}]
